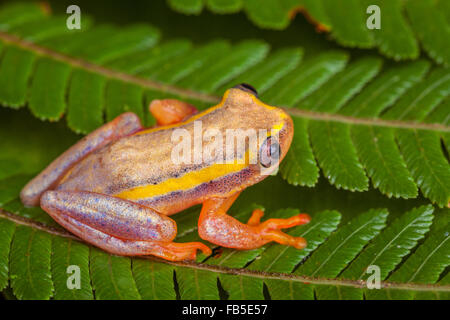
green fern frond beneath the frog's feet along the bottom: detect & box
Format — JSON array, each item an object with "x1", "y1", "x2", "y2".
[{"x1": 0, "y1": 207, "x2": 450, "y2": 299}]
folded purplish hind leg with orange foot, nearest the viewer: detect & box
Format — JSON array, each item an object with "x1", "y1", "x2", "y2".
[{"x1": 41, "y1": 191, "x2": 211, "y2": 261}]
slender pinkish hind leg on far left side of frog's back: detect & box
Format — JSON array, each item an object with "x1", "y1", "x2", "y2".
[{"x1": 20, "y1": 112, "x2": 142, "y2": 206}]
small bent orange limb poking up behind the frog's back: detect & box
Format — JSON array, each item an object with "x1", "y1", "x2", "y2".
[{"x1": 149, "y1": 99, "x2": 197, "y2": 126}]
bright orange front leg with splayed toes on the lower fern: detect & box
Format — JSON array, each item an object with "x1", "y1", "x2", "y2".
[{"x1": 198, "y1": 194, "x2": 310, "y2": 250}]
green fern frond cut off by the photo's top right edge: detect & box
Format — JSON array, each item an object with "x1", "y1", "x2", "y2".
[{"x1": 167, "y1": 0, "x2": 450, "y2": 65}]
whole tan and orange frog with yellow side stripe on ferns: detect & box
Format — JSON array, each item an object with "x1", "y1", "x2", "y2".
[{"x1": 20, "y1": 84, "x2": 310, "y2": 261}]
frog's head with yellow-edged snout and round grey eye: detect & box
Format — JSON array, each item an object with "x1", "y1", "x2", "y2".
[{"x1": 223, "y1": 84, "x2": 294, "y2": 184}]
